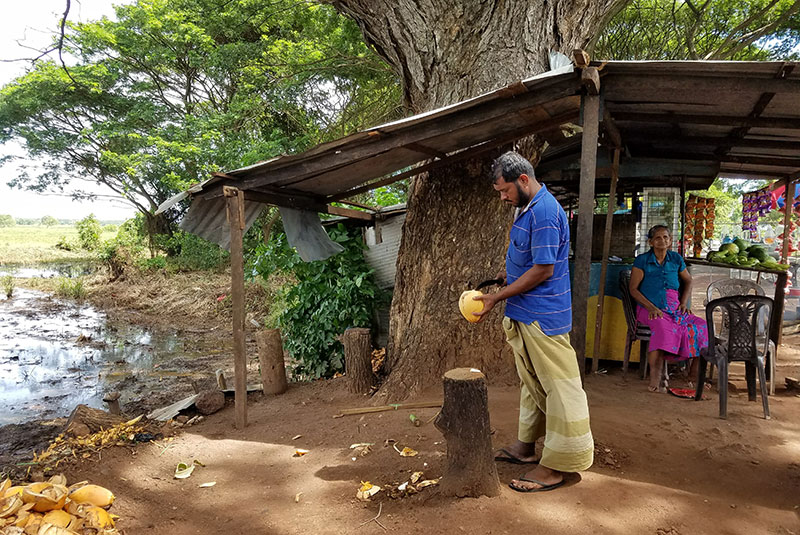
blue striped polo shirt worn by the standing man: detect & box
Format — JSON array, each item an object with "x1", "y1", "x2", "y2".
[{"x1": 506, "y1": 185, "x2": 572, "y2": 336}]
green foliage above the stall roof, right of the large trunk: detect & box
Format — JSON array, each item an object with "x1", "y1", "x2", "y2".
[{"x1": 592, "y1": 0, "x2": 800, "y2": 61}]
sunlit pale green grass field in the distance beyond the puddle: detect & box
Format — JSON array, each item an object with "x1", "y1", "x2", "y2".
[{"x1": 0, "y1": 225, "x2": 115, "y2": 265}]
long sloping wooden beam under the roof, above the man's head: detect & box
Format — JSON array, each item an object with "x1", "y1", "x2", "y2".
[{"x1": 328, "y1": 112, "x2": 578, "y2": 202}]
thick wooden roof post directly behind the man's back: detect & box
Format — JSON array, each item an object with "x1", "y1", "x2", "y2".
[{"x1": 572, "y1": 95, "x2": 600, "y2": 379}]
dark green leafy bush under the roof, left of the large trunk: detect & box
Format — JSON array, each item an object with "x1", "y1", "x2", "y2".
[{"x1": 252, "y1": 224, "x2": 388, "y2": 378}]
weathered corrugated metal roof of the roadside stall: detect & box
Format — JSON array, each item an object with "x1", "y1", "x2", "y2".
[{"x1": 173, "y1": 61, "x2": 800, "y2": 225}]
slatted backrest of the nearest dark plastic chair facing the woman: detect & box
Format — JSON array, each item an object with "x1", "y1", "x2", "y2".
[{"x1": 706, "y1": 295, "x2": 773, "y2": 361}]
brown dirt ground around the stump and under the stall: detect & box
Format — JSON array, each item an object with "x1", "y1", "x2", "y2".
[{"x1": 48, "y1": 348, "x2": 800, "y2": 535}]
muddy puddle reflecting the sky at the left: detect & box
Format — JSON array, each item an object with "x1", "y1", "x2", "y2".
[{"x1": 0, "y1": 288, "x2": 219, "y2": 426}]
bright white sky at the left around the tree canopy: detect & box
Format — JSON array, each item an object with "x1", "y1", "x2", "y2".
[{"x1": 0, "y1": 0, "x2": 135, "y2": 220}]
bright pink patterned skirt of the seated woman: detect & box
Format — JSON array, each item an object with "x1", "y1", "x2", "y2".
[{"x1": 636, "y1": 290, "x2": 708, "y2": 361}]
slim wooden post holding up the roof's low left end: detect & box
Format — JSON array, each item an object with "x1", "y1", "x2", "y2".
[{"x1": 222, "y1": 186, "x2": 247, "y2": 429}]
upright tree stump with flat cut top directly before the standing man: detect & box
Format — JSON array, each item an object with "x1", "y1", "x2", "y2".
[{"x1": 434, "y1": 368, "x2": 500, "y2": 498}]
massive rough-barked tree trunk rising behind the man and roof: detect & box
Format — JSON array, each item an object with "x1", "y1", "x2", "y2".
[{"x1": 333, "y1": 0, "x2": 626, "y2": 400}]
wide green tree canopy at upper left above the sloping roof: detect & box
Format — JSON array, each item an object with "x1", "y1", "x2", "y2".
[{"x1": 0, "y1": 0, "x2": 399, "y2": 225}]
